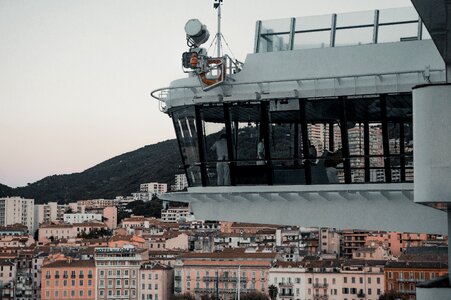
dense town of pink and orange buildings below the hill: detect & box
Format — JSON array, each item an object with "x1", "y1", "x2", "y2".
[{"x1": 0, "y1": 175, "x2": 448, "y2": 300}]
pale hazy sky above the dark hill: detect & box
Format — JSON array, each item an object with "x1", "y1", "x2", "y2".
[{"x1": 0, "y1": 0, "x2": 411, "y2": 187}]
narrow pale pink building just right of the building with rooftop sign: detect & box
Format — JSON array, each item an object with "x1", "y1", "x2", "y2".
[{"x1": 138, "y1": 263, "x2": 174, "y2": 300}]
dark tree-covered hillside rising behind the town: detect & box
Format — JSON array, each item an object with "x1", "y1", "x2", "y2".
[{"x1": 0, "y1": 139, "x2": 181, "y2": 203}]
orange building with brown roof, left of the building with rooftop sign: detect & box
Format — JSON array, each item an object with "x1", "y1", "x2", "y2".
[{"x1": 41, "y1": 259, "x2": 96, "y2": 300}]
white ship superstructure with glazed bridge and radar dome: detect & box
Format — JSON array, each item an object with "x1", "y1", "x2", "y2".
[{"x1": 152, "y1": 0, "x2": 451, "y2": 295}]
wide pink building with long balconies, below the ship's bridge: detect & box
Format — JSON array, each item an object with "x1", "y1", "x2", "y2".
[{"x1": 174, "y1": 249, "x2": 277, "y2": 300}]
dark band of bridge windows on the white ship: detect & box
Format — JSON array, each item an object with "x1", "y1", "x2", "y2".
[{"x1": 171, "y1": 94, "x2": 413, "y2": 186}]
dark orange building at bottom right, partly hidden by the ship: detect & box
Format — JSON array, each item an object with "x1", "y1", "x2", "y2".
[{"x1": 384, "y1": 261, "x2": 448, "y2": 299}]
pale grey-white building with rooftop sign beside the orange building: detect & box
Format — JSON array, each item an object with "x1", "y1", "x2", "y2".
[{"x1": 94, "y1": 246, "x2": 142, "y2": 300}]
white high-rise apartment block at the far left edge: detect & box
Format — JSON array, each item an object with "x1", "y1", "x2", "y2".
[{"x1": 0, "y1": 197, "x2": 34, "y2": 234}]
